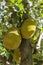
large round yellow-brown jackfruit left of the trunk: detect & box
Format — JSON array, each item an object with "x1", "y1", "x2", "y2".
[{"x1": 3, "y1": 28, "x2": 21, "y2": 50}]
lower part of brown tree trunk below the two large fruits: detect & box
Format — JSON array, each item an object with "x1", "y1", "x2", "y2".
[{"x1": 20, "y1": 39, "x2": 32, "y2": 65}]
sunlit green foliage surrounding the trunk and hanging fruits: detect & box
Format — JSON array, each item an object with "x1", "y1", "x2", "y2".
[{"x1": 0, "y1": 0, "x2": 43, "y2": 65}]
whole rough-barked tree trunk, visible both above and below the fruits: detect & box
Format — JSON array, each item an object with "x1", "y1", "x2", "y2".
[{"x1": 20, "y1": 0, "x2": 32, "y2": 65}]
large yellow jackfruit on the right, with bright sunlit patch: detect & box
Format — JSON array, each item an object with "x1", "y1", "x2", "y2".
[{"x1": 21, "y1": 19, "x2": 36, "y2": 39}]
